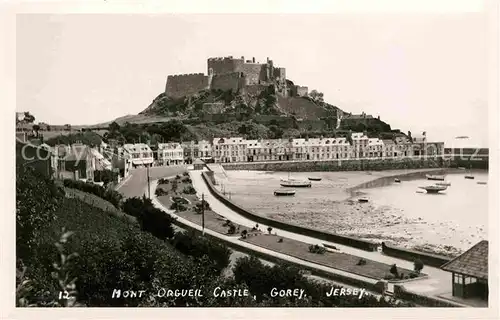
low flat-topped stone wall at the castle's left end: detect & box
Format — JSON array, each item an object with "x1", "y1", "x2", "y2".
[{"x1": 165, "y1": 73, "x2": 209, "y2": 98}]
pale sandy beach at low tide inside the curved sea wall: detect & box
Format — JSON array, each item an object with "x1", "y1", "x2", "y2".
[{"x1": 215, "y1": 169, "x2": 487, "y2": 256}]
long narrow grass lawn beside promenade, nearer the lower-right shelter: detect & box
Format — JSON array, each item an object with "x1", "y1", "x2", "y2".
[{"x1": 242, "y1": 234, "x2": 424, "y2": 280}]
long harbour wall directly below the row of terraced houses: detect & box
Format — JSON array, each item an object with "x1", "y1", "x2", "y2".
[{"x1": 221, "y1": 158, "x2": 443, "y2": 172}]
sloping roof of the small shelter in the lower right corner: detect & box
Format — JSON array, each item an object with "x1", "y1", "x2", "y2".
[{"x1": 441, "y1": 240, "x2": 488, "y2": 279}]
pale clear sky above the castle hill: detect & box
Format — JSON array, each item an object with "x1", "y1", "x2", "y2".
[{"x1": 16, "y1": 13, "x2": 488, "y2": 146}]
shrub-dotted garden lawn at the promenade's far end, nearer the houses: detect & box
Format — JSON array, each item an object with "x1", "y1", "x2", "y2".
[{"x1": 157, "y1": 175, "x2": 261, "y2": 237}]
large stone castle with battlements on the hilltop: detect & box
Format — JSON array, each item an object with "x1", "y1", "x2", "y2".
[{"x1": 165, "y1": 56, "x2": 308, "y2": 98}]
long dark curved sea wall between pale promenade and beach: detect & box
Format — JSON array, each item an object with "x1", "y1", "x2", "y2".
[{"x1": 202, "y1": 172, "x2": 378, "y2": 251}]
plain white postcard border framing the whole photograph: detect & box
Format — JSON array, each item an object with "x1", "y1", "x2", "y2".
[{"x1": 0, "y1": 0, "x2": 500, "y2": 319}]
